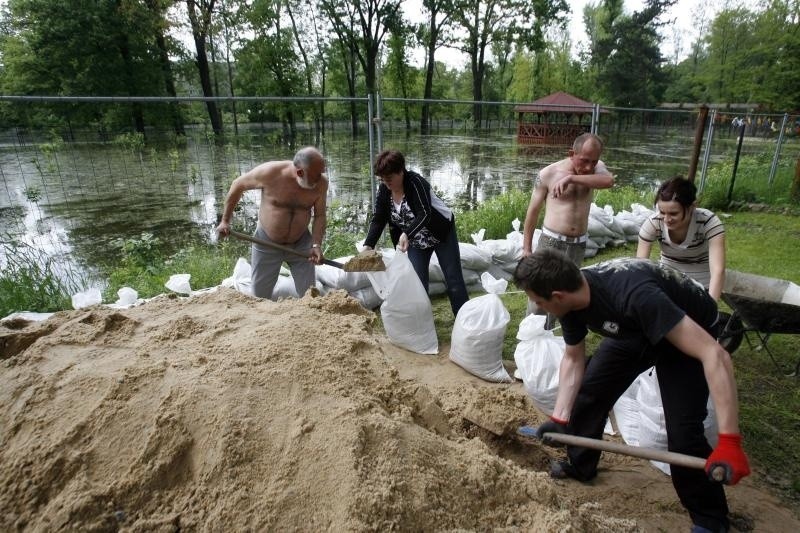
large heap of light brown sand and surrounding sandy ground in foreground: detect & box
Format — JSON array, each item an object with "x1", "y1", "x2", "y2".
[{"x1": 0, "y1": 289, "x2": 800, "y2": 532}]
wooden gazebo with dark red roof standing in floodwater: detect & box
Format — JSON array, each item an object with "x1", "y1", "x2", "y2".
[{"x1": 514, "y1": 91, "x2": 594, "y2": 145}]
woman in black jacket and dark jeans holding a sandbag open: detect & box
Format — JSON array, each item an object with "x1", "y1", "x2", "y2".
[{"x1": 364, "y1": 150, "x2": 469, "y2": 315}]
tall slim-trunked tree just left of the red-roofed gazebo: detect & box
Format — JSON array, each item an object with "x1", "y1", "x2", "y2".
[{"x1": 453, "y1": 0, "x2": 567, "y2": 127}]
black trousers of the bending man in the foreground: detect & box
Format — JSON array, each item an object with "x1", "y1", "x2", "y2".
[{"x1": 567, "y1": 338, "x2": 729, "y2": 531}]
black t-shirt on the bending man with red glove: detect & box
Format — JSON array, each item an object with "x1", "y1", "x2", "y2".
[{"x1": 560, "y1": 258, "x2": 718, "y2": 345}]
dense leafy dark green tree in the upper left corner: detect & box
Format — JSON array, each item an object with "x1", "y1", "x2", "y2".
[{"x1": 2, "y1": 0, "x2": 163, "y2": 131}]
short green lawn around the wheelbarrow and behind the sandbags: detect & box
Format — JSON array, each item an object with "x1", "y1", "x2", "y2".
[{"x1": 432, "y1": 207, "x2": 800, "y2": 507}]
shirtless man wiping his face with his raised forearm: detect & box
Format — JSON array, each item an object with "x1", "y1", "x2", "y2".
[{"x1": 522, "y1": 133, "x2": 614, "y2": 329}]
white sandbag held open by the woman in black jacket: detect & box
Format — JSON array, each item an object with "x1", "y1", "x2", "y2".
[{"x1": 367, "y1": 252, "x2": 439, "y2": 354}]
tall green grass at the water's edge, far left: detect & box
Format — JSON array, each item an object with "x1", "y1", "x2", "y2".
[{"x1": 0, "y1": 234, "x2": 84, "y2": 317}]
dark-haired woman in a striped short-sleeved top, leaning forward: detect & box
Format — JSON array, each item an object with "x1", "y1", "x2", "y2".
[{"x1": 636, "y1": 176, "x2": 725, "y2": 301}]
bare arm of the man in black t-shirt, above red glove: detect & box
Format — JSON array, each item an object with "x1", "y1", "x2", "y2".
[{"x1": 666, "y1": 315, "x2": 739, "y2": 435}]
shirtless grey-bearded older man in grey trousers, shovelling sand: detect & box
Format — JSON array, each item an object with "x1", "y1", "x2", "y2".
[{"x1": 217, "y1": 146, "x2": 328, "y2": 298}]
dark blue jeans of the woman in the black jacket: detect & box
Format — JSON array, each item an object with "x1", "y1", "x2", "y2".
[{"x1": 408, "y1": 222, "x2": 469, "y2": 316}]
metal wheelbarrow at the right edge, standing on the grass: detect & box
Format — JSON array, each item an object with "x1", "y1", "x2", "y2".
[{"x1": 720, "y1": 270, "x2": 800, "y2": 377}]
